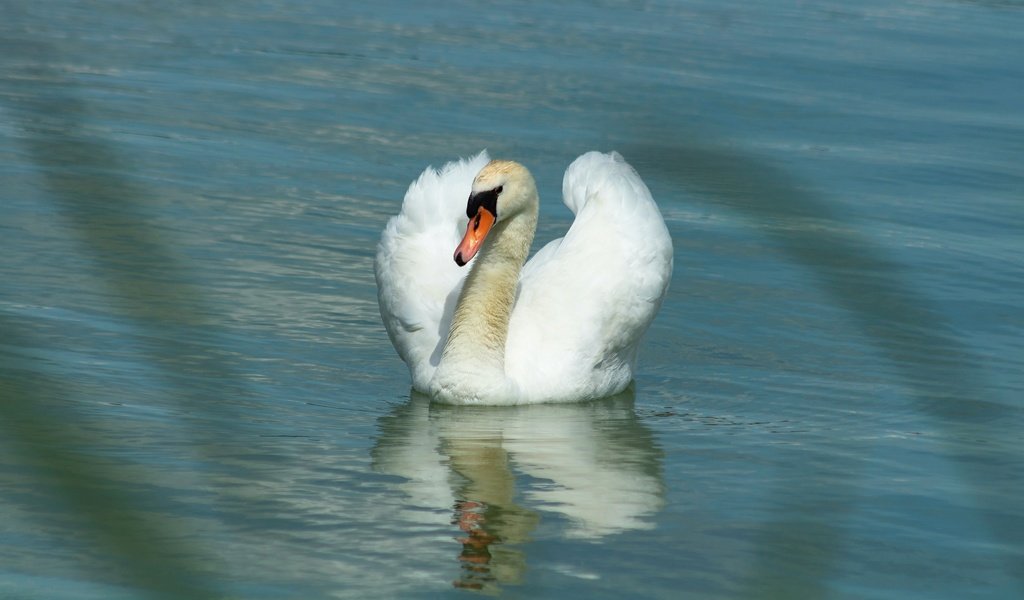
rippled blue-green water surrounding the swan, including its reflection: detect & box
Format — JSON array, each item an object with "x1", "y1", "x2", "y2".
[{"x1": 0, "y1": 0, "x2": 1024, "y2": 599}]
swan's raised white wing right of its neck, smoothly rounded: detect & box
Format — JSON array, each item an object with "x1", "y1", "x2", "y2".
[{"x1": 506, "y1": 153, "x2": 673, "y2": 399}]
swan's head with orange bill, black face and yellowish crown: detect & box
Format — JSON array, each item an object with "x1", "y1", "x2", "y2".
[{"x1": 455, "y1": 161, "x2": 537, "y2": 266}]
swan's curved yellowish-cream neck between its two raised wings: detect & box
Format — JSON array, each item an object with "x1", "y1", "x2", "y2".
[{"x1": 435, "y1": 205, "x2": 537, "y2": 399}]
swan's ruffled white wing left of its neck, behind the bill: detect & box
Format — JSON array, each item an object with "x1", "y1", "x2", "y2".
[{"x1": 374, "y1": 152, "x2": 490, "y2": 391}]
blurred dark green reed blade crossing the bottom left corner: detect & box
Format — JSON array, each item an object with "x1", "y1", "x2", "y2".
[{"x1": 0, "y1": 327, "x2": 221, "y2": 599}]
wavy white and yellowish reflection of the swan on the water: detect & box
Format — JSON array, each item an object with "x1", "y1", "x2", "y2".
[{"x1": 373, "y1": 388, "x2": 665, "y2": 589}]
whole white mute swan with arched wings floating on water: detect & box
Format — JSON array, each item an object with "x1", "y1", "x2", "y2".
[{"x1": 374, "y1": 152, "x2": 673, "y2": 404}]
